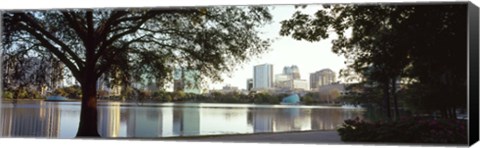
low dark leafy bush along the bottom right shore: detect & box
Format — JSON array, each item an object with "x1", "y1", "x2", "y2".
[{"x1": 338, "y1": 118, "x2": 468, "y2": 144}]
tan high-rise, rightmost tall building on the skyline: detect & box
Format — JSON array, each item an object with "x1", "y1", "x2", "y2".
[{"x1": 310, "y1": 68, "x2": 335, "y2": 90}]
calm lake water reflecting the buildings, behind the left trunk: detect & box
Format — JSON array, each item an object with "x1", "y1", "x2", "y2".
[{"x1": 0, "y1": 101, "x2": 363, "y2": 138}]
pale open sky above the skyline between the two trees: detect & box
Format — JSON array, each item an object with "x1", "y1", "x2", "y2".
[{"x1": 208, "y1": 5, "x2": 346, "y2": 89}]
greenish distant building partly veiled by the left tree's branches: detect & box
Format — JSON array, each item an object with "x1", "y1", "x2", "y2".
[{"x1": 173, "y1": 69, "x2": 202, "y2": 94}]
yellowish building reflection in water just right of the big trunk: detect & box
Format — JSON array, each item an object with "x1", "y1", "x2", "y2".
[{"x1": 98, "y1": 102, "x2": 120, "y2": 137}]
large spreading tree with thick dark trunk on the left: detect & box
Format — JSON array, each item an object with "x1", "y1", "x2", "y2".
[{"x1": 3, "y1": 7, "x2": 271, "y2": 137}]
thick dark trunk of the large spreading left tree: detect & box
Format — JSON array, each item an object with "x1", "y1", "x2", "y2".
[{"x1": 77, "y1": 76, "x2": 100, "y2": 137}]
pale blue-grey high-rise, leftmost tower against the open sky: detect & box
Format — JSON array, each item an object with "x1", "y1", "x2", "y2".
[{"x1": 253, "y1": 64, "x2": 273, "y2": 89}]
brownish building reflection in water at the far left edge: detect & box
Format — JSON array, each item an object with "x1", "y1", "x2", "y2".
[{"x1": 0, "y1": 102, "x2": 60, "y2": 138}]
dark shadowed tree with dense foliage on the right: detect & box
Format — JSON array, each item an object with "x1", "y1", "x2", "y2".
[{"x1": 280, "y1": 3, "x2": 467, "y2": 118}]
